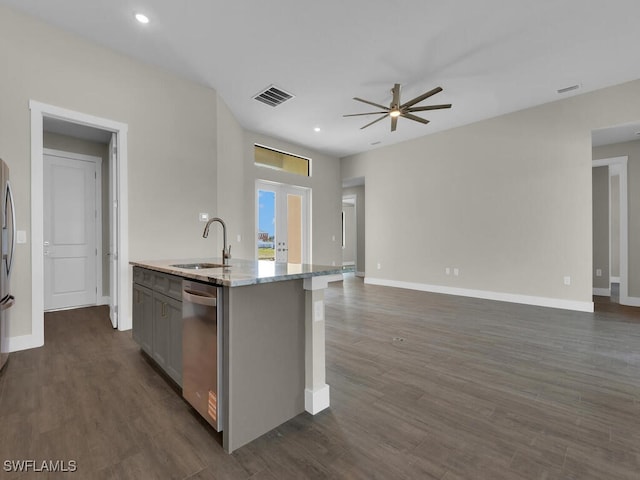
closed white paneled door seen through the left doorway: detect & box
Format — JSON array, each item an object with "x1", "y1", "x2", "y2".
[{"x1": 44, "y1": 154, "x2": 99, "y2": 310}]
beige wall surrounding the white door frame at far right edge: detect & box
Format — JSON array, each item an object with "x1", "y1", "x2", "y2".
[{"x1": 593, "y1": 139, "x2": 640, "y2": 297}]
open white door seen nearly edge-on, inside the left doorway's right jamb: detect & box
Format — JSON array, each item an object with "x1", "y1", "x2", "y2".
[{"x1": 109, "y1": 133, "x2": 118, "y2": 328}]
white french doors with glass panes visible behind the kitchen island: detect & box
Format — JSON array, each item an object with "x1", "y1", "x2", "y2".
[{"x1": 256, "y1": 180, "x2": 311, "y2": 263}]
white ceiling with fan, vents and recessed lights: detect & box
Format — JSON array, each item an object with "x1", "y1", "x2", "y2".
[{"x1": 5, "y1": 0, "x2": 640, "y2": 156}]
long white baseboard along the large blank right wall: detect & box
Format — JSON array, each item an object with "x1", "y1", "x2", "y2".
[{"x1": 364, "y1": 277, "x2": 593, "y2": 312}]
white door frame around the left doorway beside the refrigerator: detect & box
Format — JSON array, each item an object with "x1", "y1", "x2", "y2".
[{"x1": 29, "y1": 100, "x2": 131, "y2": 350}]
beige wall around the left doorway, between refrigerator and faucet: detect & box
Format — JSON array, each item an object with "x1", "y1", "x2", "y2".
[{"x1": 0, "y1": 7, "x2": 217, "y2": 337}]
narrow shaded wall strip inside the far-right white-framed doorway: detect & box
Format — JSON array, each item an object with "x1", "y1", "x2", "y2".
[{"x1": 592, "y1": 167, "x2": 610, "y2": 288}]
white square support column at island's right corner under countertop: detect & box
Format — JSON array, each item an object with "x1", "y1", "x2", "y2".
[{"x1": 304, "y1": 276, "x2": 329, "y2": 415}]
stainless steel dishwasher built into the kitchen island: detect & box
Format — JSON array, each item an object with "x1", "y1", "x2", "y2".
[{"x1": 182, "y1": 279, "x2": 222, "y2": 432}]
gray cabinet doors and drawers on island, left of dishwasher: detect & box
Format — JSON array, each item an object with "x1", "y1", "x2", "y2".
[{"x1": 133, "y1": 267, "x2": 182, "y2": 386}]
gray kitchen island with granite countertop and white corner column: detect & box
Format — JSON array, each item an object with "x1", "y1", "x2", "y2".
[{"x1": 131, "y1": 259, "x2": 352, "y2": 453}]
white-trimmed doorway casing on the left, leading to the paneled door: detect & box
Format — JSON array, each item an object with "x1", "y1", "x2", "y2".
[{"x1": 29, "y1": 100, "x2": 131, "y2": 348}]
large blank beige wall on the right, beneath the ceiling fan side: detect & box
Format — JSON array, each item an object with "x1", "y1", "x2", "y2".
[{"x1": 342, "y1": 81, "x2": 640, "y2": 302}]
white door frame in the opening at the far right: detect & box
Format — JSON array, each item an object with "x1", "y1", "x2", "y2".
[{"x1": 592, "y1": 156, "x2": 640, "y2": 307}]
